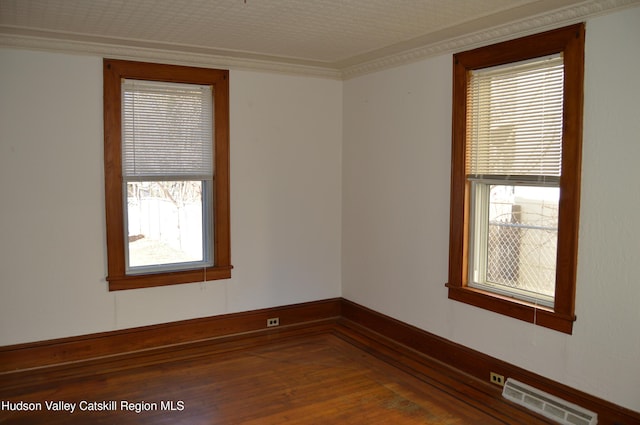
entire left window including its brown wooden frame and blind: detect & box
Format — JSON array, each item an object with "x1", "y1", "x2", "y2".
[{"x1": 104, "y1": 60, "x2": 231, "y2": 290}]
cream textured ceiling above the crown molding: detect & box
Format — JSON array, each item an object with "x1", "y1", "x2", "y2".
[{"x1": 0, "y1": 0, "x2": 634, "y2": 76}]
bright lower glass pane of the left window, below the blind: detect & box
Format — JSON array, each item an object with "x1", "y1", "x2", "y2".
[{"x1": 127, "y1": 181, "x2": 206, "y2": 268}]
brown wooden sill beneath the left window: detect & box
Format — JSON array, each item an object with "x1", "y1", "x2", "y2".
[{"x1": 107, "y1": 266, "x2": 233, "y2": 291}]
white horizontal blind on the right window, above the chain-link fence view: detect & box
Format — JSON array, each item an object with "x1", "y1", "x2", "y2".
[{"x1": 466, "y1": 54, "x2": 564, "y2": 183}]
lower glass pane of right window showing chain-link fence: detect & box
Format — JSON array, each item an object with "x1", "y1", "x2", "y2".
[{"x1": 486, "y1": 185, "x2": 560, "y2": 299}]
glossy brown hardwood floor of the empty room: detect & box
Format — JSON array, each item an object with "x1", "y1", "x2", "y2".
[{"x1": 0, "y1": 322, "x2": 548, "y2": 425}]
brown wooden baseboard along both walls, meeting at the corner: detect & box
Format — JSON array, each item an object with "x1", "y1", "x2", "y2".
[{"x1": 0, "y1": 298, "x2": 640, "y2": 425}]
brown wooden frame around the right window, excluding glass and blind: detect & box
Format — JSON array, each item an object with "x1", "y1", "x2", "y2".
[{"x1": 447, "y1": 24, "x2": 585, "y2": 334}]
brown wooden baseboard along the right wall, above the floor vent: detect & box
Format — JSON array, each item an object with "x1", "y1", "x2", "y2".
[{"x1": 339, "y1": 299, "x2": 640, "y2": 425}]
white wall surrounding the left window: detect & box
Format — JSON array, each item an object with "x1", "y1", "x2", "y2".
[{"x1": 0, "y1": 49, "x2": 342, "y2": 345}]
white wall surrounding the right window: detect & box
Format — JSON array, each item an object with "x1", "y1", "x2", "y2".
[{"x1": 342, "y1": 7, "x2": 640, "y2": 411}]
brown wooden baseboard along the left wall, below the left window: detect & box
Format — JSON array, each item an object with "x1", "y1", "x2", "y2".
[{"x1": 0, "y1": 298, "x2": 341, "y2": 375}]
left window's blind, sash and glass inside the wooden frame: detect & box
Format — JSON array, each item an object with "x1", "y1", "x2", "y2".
[{"x1": 122, "y1": 79, "x2": 213, "y2": 274}]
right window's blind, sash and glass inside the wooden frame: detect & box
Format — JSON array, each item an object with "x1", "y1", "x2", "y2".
[{"x1": 466, "y1": 54, "x2": 564, "y2": 307}]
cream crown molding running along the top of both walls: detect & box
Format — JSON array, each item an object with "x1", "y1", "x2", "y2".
[{"x1": 0, "y1": 0, "x2": 640, "y2": 80}]
